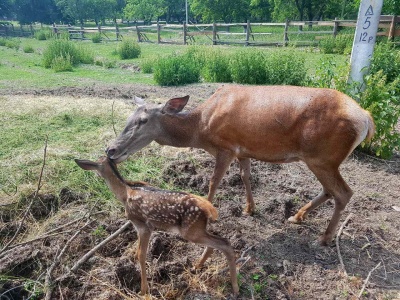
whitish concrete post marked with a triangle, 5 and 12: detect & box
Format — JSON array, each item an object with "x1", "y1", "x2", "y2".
[{"x1": 349, "y1": 0, "x2": 383, "y2": 89}]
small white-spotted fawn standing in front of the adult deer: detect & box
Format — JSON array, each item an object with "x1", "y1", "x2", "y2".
[{"x1": 75, "y1": 157, "x2": 239, "y2": 296}]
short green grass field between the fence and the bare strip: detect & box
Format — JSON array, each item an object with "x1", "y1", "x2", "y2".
[{"x1": 0, "y1": 38, "x2": 348, "y2": 89}]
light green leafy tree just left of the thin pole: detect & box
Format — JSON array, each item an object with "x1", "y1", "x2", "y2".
[{"x1": 124, "y1": 0, "x2": 167, "y2": 22}]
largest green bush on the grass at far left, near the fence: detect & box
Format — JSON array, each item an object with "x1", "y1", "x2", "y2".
[{"x1": 43, "y1": 40, "x2": 94, "y2": 68}]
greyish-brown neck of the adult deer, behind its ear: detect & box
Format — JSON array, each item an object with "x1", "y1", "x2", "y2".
[{"x1": 156, "y1": 110, "x2": 200, "y2": 147}]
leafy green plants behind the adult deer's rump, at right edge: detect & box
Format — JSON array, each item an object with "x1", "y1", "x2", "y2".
[{"x1": 358, "y1": 70, "x2": 400, "y2": 159}]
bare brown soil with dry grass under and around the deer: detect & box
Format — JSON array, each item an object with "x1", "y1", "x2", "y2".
[{"x1": 0, "y1": 84, "x2": 400, "y2": 300}]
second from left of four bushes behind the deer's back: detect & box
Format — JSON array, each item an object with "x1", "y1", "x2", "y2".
[{"x1": 201, "y1": 49, "x2": 232, "y2": 82}]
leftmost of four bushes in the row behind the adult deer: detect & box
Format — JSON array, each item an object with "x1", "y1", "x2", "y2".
[{"x1": 153, "y1": 53, "x2": 200, "y2": 85}]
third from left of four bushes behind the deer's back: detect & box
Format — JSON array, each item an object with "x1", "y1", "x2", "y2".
[{"x1": 229, "y1": 49, "x2": 266, "y2": 84}]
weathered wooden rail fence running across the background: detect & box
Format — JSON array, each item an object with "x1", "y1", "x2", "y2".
[{"x1": 0, "y1": 16, "x2": 400, "y2": 46}]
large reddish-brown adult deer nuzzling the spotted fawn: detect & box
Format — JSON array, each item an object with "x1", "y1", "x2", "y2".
[{"x1": 106, "y1": 85, "x2": 375, "y2": 245}]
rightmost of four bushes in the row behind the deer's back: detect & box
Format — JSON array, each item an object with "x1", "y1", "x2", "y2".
[{"x1": 265, "y1": 51, "x2": 307, "y2": 85}]
